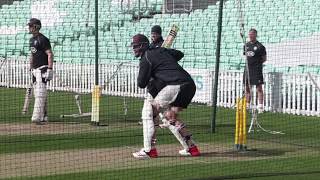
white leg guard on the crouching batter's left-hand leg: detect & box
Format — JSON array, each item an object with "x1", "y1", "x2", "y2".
[{"x1": 141, "y1": 99, "x2": 155, "y2": 152}]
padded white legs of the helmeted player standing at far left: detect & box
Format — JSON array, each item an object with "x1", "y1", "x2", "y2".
[{"x1": 31, "y1": 66, "x2": 47, "y2": 123}]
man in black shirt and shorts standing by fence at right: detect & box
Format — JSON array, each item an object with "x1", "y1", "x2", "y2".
[{"x1": 244, "y1": 29, "x2": 267, "y2": 113}]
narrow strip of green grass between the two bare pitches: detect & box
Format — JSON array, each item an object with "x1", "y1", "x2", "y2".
[{"x1": 0, "y1": 128, "x2": 228, "y2": 154}]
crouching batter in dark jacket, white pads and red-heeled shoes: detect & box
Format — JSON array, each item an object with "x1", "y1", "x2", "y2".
[{"x1": 131, "y1": 34, "x2": 200, "y2": 159}]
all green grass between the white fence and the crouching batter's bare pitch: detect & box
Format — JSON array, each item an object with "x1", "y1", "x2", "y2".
[{"x1": 0, "y1": 88, "x2": 320, "y2": 153}]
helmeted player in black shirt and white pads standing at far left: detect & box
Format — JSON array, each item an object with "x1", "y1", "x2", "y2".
[{"x1": 27, "y1": 18, "x2": 53, "y2": 124}]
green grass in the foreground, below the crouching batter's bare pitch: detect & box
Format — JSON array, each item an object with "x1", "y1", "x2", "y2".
[{"x1": 8, "y1": 156, "x2": 320, "y2": 180}]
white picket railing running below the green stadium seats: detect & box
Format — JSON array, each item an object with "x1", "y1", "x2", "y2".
[{"x1": 0, "y1": 59, "x2": 320, "y2": 116}]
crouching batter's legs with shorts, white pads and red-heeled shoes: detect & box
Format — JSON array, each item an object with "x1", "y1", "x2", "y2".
[{"x1": 133, "y1": 84, "x2": 200, "y2": 159}]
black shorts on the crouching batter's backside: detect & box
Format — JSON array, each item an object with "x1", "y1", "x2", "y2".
[{"x1": 170, "y1": 82, "x2": 196, "y2": 108}]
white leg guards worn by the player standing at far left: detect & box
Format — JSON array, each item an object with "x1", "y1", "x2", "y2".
[{"x1": 31, "y1": 70, "x2": 47, "y2": 122}]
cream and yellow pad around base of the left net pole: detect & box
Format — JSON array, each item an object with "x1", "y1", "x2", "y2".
[{"x1": 91, "y1": 85, "x2": 101, "y2": 123}]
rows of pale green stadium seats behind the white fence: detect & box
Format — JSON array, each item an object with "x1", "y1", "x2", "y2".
[{"x1": 0, "y1": 0, "x2": 320, "y2": 72}]
